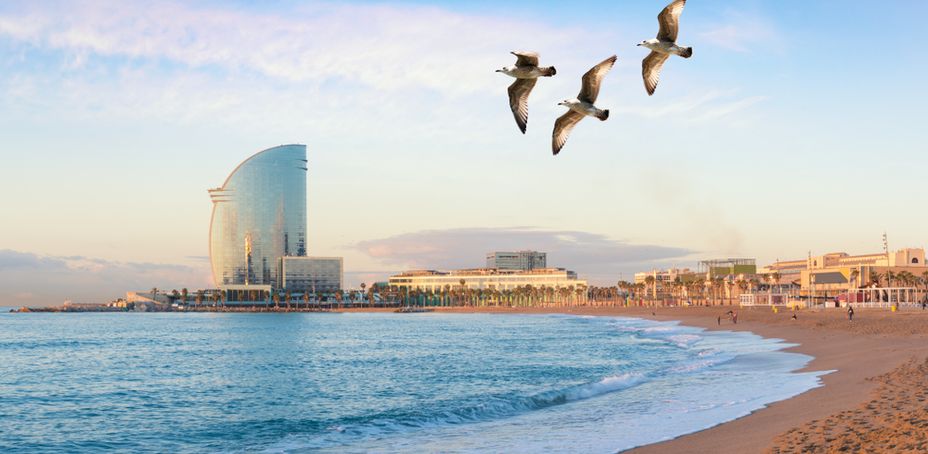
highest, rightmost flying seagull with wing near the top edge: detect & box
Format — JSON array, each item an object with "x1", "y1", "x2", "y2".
[{"x1": 638, "y1": 0, "x2": 693, "y2": 96}]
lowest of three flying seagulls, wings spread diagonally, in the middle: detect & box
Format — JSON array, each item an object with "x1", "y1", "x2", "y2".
[{"x1": 551, "y1": 55, "x2": 616, "y2": 155}]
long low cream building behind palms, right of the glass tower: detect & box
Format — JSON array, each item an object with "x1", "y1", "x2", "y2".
[{"x1": 389, "y1": 268, "x2": 587, "y2": 292}]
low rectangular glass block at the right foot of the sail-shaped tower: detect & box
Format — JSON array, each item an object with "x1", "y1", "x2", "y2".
[{"x1": 277, "y1": 257, "x2": 345, "y2": 294}]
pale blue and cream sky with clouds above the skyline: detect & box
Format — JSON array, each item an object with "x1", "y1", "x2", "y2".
[{"x1": 0, "y1": 0, "x2": 928, "y2": 305}]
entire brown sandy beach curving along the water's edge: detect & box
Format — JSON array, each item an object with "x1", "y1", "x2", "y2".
[{"x1": 346, "y1": 306, "x2": 928, "y2": 453}]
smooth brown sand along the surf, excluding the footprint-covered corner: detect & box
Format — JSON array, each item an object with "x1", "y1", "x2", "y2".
[{"x1": 345, "y1": 306, "x2": 928, "y2": 454}]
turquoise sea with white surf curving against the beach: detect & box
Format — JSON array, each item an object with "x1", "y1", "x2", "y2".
[{"x1": 0, "y1": 313, "x2": 820, "y2": 452}]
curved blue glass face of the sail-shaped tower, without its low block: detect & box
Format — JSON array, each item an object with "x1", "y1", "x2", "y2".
[{"x1": 209, "y1": 145, "x2": 307, "y2": 287}]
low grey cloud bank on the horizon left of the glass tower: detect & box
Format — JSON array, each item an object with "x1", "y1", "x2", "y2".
[{"x1": 0, "y1": 249, "x2": 210, "y2": 306}]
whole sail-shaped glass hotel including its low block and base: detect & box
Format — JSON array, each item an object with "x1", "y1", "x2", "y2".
[{"x1": 209, "y1": 144, "x2": 344, "y2": 301}]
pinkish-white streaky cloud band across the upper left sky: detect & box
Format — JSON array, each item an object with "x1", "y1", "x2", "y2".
[{"x1": 0, "y1": 1, "x2": 596, "y2": 95}]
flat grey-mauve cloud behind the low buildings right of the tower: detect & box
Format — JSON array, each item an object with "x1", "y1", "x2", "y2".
[{"x1": 355, "y1": 227, "x2": 693, "y2": 284}]
